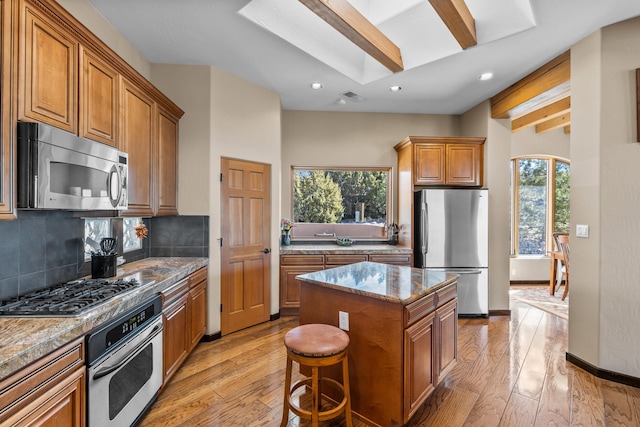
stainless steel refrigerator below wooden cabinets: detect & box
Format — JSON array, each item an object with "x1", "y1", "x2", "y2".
[{"x1": 414, "y1": 189, "x2": 489, "y2": 317}]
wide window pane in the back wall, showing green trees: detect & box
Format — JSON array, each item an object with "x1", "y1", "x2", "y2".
[{"x1": 292, "y1": 167, "x2": 391, "y2": 240}]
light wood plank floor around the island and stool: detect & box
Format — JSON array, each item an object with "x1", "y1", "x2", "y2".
[{"x1": 140, "y1": 294, "x2": 640, "y2": 427}]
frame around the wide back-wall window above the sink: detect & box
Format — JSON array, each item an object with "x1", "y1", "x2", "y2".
[{"x1": 288, "y1": 165, "x2": 393, "y2": 242}]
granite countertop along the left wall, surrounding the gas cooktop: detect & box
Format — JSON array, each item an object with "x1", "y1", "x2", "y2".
[{"x1": 0, "y1": 258, "x2": 209, "y2": 379}]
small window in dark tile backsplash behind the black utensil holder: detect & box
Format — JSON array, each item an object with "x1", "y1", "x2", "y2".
[{"x1": 84, "y1": 218, "x2": 142, "y2": 261}]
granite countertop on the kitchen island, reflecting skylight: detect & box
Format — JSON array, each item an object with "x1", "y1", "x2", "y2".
[{"x1": 296, "y1": 261, "x2": 458, "y2": 305}]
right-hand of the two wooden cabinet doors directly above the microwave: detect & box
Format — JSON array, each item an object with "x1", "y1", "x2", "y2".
[{"x1": 80, "y1": 48, "x2": 119, "y2": 147}]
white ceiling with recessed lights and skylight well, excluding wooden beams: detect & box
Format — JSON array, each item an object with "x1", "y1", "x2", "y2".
[{"x1": 89, "y1": 0, "x2": 640, "y2": 114}]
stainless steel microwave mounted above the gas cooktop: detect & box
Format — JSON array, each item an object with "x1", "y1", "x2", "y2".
[{"x1": 17, "y1": 122, "x2": 128, "y2": 210}]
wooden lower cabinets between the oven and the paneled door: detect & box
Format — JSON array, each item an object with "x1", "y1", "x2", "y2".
[{"x1": 162, "y1": 267, "x2": 207, "y2": 387}]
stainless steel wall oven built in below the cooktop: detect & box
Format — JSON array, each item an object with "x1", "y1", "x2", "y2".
[{"x1": 87, "y1": 296, "x2": 162, "y2": 427}]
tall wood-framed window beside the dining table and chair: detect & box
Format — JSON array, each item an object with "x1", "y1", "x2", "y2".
[{"x1": 511, "y1": 157, "x2": 570, "y2": 255}]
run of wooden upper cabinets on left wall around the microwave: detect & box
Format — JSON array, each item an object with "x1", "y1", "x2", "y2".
[{"x1": 10, "y1": 0, "x2": 184, "y2": 218}]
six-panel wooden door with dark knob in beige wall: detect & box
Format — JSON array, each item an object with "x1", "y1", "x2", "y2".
[{"x1": 220, "y1": 159, "x2": 271, "y2": 335}]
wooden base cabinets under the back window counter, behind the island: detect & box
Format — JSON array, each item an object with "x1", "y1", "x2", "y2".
[{"x1": 280, "y1": 254, "x2": 411, "y2": 316}]
